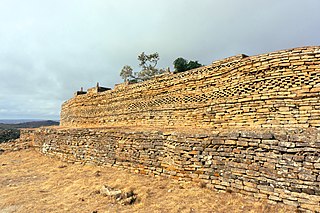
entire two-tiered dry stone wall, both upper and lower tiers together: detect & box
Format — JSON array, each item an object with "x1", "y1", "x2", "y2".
[{"x1": 21, "y1": 47, "x2": 320, "y2": 212}]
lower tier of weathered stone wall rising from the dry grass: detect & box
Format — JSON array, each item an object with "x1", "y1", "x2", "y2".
[{"x1": 26, "y1": 128, "x2": 320, "y2": 211}]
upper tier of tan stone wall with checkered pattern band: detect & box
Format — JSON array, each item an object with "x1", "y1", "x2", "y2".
[{"x1": 61, "y1": 47, "x2": 320, "y2": 127}]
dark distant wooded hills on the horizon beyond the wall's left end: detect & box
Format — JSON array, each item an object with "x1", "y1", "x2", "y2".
[{"x1": 0, "y1": 120, "x2": 59, "y2": 143}]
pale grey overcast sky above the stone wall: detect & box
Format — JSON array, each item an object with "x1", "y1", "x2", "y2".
[{"x1": 0, "y1": 0, "x2": 320, "y2": 119}]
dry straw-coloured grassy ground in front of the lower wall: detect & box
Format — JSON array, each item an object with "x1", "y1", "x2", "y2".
[{"x1": 0, "y1": 150, "x2": 295, "y2": 213}]
